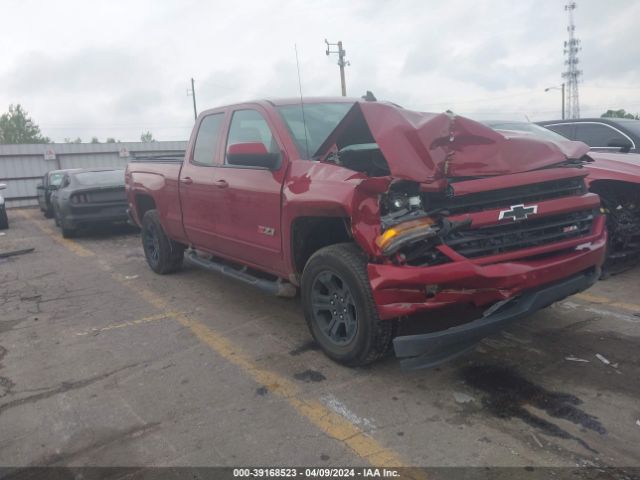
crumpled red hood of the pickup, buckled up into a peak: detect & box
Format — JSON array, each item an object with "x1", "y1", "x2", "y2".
[{"x1": 316, "y1": 102, "x2": 589, "y2": 182}]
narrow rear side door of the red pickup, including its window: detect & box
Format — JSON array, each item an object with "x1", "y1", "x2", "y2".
[{"x1": 179, "y1": 112, "x2": 224, "y2": 251}]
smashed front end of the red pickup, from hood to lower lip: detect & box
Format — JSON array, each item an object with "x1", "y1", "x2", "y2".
[{"x1": 318, "y1": 103, "x2": 606, "y2": 368}]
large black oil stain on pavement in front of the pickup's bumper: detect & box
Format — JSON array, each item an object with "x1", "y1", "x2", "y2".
[{"x1": 462, "y1": 365, "x2": 607, "y2": 453}]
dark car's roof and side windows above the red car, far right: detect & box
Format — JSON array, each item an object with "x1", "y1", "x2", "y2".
[{"x1": 537, "y1": 118, "x2": 640, "y2": 153}]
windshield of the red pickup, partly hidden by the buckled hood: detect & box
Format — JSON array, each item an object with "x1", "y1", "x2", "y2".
[{"x1": 278, "y1": 102, "x2": 353, "y2": 159}]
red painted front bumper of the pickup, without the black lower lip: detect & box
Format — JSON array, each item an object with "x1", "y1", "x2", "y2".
[{"x1": 367, "y1": 216, "x2": 607, "y2": 320}]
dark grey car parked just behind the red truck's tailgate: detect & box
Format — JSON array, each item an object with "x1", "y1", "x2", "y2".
[{"x1": 51, "y1": 169, "x2": 128, "y2": 238}]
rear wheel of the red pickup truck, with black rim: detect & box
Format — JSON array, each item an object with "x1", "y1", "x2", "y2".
[{"x1": 141, "y1": 210, "x2": 184, "y2": 275}]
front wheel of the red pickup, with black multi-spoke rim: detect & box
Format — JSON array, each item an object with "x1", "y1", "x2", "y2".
[{"x1": 301, "y1": 243, "x2": 394, "y2": 367}]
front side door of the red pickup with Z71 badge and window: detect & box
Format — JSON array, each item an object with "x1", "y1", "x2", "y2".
[{"x1": 215, "y1": 107, "x2": 286, "y2": 272}]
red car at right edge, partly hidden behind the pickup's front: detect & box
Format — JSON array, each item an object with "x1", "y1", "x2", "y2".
[{"x1": 484, "y1": 121, "x2": 640, "y2": 276}]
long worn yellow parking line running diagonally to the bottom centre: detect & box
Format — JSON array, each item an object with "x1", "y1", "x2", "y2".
[{"x1": 25, "y1": 210, "x2": 428, "y2": 480}]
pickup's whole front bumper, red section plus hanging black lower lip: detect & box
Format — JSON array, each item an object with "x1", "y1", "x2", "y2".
[{"x1": 368, "y1": 216, "x2": 607, "y2": 369}]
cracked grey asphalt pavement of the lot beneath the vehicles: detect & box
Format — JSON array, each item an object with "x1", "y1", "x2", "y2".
[{"x1": 0, "y1": 209, "x2": 640, "y2": 467}]
